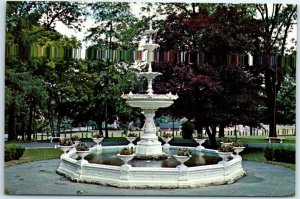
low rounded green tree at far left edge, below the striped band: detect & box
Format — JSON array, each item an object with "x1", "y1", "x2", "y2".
[{"x1": 5, "y1": 63, "x2": 48, "y2": 140}]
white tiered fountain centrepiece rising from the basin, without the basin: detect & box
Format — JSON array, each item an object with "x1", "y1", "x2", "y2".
[{"x1": 122, "y1": 22, "x2": 178, "y2": 157}]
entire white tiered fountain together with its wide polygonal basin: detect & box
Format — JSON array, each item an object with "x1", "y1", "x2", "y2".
[{"x1": 57, "y1": 17, "x2": 245, "y2": 188}]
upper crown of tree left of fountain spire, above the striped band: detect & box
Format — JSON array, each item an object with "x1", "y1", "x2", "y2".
[{"x1": 86, "y1": 2, "x2": 141, "y2": 49}]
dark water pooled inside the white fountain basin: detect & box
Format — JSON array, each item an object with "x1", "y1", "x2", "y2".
[{"x1": 85, "y1": 150, "x2": 221, "y2": 168}]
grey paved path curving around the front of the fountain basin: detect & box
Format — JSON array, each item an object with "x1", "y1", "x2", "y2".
[{"x1": 4, "y1": 159, "x2": 295, "y2": 197}]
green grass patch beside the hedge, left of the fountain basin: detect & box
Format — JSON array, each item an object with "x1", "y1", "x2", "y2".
[{"x1": 4, "y1": 149, "x2": 62, "y2": 167}]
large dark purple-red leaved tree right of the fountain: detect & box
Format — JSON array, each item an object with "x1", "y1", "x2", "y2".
[{"x1": 155, "y1": 5, "x2": 261, "y2": 147}]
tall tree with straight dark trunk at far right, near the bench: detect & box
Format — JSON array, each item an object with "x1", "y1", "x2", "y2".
[{"x1": 256, "y1": 4, "x2": 297, "y2": 137}]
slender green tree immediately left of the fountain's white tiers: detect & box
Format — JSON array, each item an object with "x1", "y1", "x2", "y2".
[{"x1": 86, "y1": 2, "x2": 142, "y2": 137}]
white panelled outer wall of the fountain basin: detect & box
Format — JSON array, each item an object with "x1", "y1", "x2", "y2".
[{"x1": 57, "y1": 146, "x2": 245, "y2": 188}]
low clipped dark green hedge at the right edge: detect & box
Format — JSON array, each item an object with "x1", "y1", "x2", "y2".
[{"x1": 264, "y1": 147, "x2": 296, "y2": 164}]
